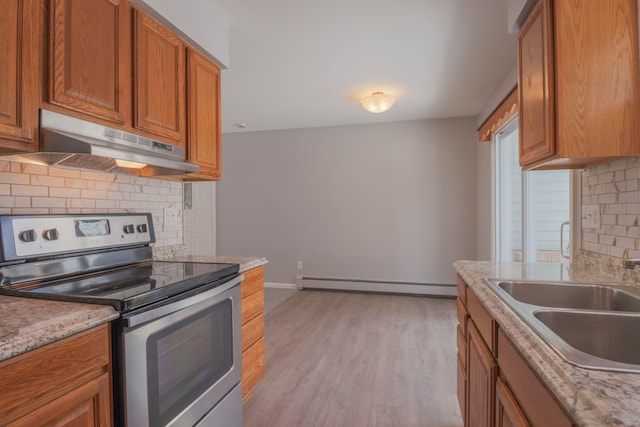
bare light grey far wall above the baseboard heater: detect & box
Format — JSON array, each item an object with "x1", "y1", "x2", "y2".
[{"x1": 217, "y1": 117, "x2": 477, "y2": 284}]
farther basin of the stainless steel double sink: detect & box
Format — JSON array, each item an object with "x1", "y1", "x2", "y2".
[{"x1": 498, "y1": 281, "x2": 640, "y2": 312}]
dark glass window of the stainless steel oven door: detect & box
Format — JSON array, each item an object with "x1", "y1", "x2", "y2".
[{"x1": 147, "y1": 299, "x2": 233, "y2": 426}]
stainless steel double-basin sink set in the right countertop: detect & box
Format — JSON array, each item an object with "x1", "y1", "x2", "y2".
[{"x1": 484, "y1": 279, "x2": 640, "y2": 373}]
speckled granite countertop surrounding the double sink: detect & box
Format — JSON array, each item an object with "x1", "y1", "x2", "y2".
[{"x1": 454, "y1": 261, "x2": 640, "y2": 427}]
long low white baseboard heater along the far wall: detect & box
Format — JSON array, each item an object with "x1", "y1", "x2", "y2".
[{"x1": 296, "y1": 276, "x2": 457, "y2": 298}]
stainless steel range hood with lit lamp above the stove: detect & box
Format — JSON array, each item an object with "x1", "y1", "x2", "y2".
[{"x1": 0, "y1": 110, "x2": 200, "y2": 176}]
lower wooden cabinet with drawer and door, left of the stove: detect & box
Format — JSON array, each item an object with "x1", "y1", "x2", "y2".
[{"x1": 0, "y1": 324, "x2": 113, "y2": 427}]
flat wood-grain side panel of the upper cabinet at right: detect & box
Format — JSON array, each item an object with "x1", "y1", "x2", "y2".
[{"x1": 554, "y1": 0, "x2": 640, "y2": 158}]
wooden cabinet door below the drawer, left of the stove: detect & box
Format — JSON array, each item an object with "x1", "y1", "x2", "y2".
[{"x1": 7, "y1": 373, "x2": 113, "y2": 427}]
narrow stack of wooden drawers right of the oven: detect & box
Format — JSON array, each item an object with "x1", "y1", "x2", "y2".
[{"x1": 240, "y1": 267, "x2": 264, "y2": 403}]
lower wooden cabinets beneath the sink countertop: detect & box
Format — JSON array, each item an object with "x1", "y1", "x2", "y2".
[{"x1": 457, "y1": 276, "x2": 576, "y2": 427}]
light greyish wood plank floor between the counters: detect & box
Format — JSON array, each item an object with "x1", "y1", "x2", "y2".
[{"x1": 244, "y1": 291, "x2": 462, "y2": 427}]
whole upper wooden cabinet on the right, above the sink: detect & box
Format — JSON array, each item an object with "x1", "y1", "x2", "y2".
[{"x1": 518, "y1": 0, "x2": 640, "y2": 169}]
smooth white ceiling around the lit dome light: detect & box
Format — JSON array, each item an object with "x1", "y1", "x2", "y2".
[{"x1": 209, "y1": 0, "x2": 516, "y2": 133}]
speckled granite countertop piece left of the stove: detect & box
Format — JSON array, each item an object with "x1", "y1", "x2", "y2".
[{"x1": 0, "y1": 295, "x2": 119, "y2": 361}]
